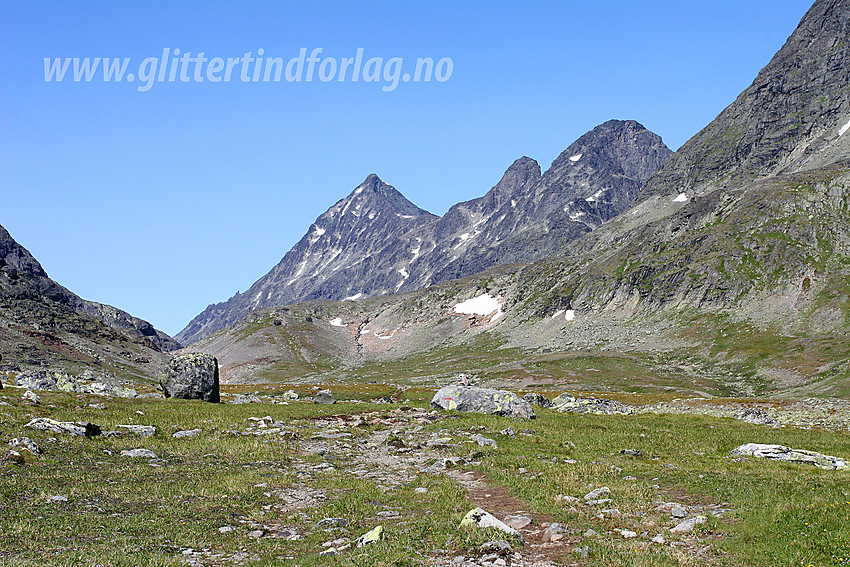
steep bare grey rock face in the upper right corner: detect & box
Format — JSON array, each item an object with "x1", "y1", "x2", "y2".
[{"x1": 641, "y1": 0, "x2": 850, "y2": 202}]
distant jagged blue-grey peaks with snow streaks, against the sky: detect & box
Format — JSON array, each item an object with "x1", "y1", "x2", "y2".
[{"x1": 176, "y1": 120, "x2": 672, "y2": 344}]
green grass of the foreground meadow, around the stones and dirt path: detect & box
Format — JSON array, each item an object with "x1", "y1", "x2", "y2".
[{"x1": 0, "y1": 384, "x2": 850, "y2": 567}]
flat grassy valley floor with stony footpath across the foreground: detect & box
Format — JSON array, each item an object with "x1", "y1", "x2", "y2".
[{"x1": 0, "y1": 386, "x2": 850, "y2": 567}]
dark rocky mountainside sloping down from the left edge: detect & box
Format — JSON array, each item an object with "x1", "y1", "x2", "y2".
[{"x1": 0, "y1": 226, "x2": 180, "y2": 382}]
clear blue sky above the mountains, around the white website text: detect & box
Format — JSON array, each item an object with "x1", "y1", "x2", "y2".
[{"x1": 0, "y1": 0, "x2": 810, "y2": 334}]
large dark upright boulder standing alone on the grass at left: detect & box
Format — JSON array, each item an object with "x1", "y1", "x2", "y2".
[{"x1": 159, "y1": 353, "x2": 221, "y2": 403}]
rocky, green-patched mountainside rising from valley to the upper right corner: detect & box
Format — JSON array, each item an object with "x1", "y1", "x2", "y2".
[{"x1": 189, "y1": 0, "x2": 850, "y2": 396}]
